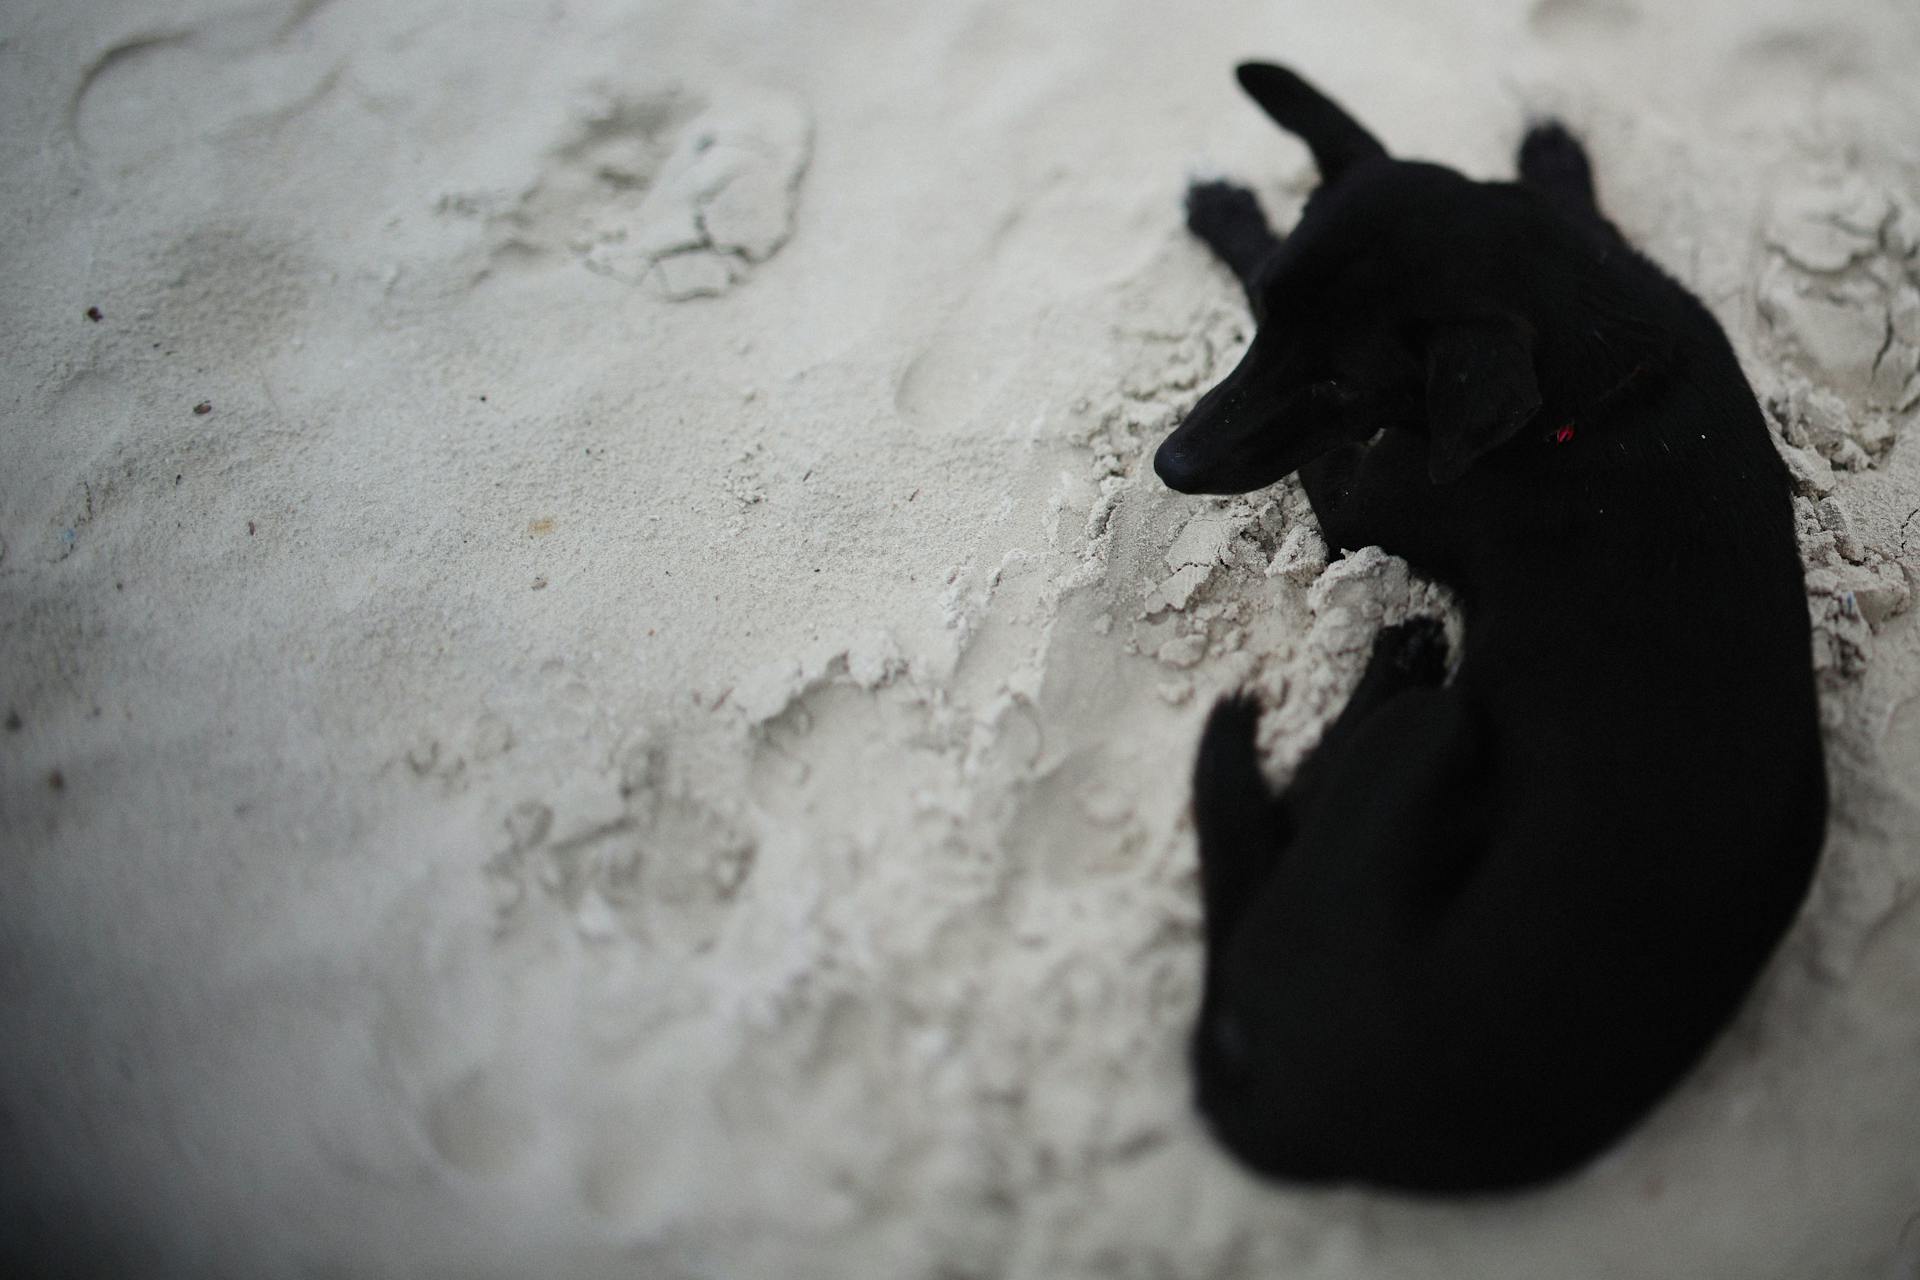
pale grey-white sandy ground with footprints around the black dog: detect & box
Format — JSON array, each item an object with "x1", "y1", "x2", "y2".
[{"x1": 0, "y1": 0, "x2": 1920, "y2": 1280}]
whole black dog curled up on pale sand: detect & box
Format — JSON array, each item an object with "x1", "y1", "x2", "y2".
[{"x1": 1154, "y1": 65, "x2": 1826, "y2": 1192}]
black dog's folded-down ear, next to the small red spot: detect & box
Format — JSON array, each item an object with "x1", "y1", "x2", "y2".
[{"x1": 1427, "y1": 315, "x2": 1540, "y2": 484}]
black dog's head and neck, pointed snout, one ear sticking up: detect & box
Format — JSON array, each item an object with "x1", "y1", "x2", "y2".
[{"x1": 1154, "y1": 63, "x2": 1649, "y2": 493}]
